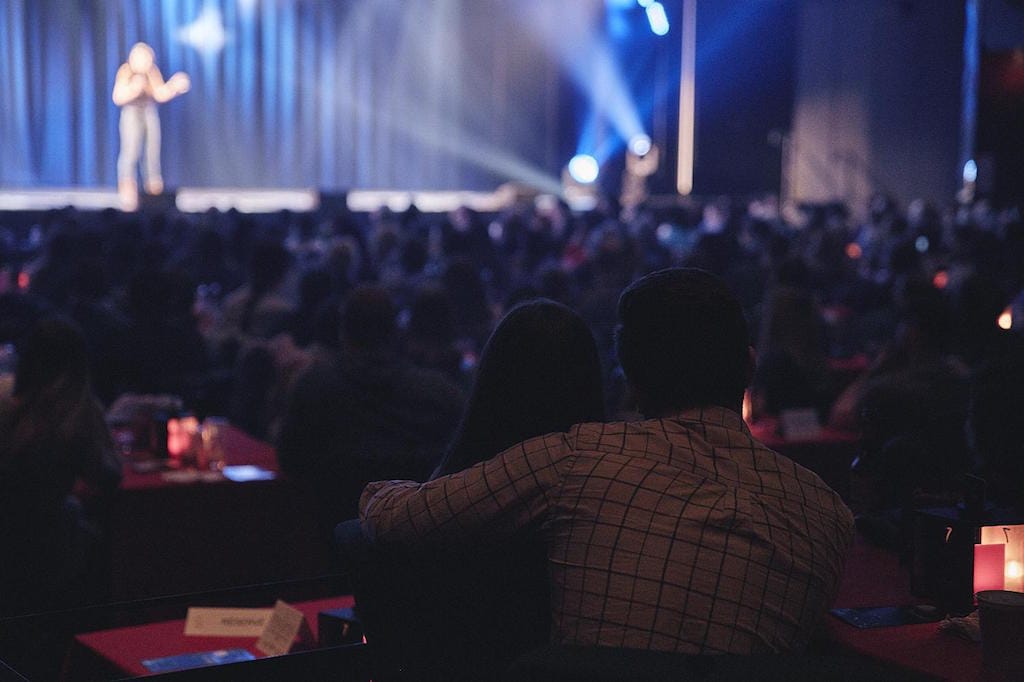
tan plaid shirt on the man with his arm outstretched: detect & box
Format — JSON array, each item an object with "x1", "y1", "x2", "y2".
[{"x1": 359, "y1": 408, "x2": 853, "y2": 653}]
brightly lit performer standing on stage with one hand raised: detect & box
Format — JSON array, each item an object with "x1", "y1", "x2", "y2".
[{"x1": 113, "y1": 43, "x2": 190, "y2": 211}]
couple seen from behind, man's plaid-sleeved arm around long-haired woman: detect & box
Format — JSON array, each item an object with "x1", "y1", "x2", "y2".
[{"x1": 338, "y1": 268, "x2": 853, "y2": 679}]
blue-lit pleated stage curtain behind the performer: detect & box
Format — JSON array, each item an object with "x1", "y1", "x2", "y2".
[{"x1": 0, "y1": 0, "x2": 563, "y2": 188}]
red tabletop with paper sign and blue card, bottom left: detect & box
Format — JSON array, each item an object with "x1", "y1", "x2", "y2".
[{"x1": 62, "y1": 595, "x2": 355, "y2": 680}]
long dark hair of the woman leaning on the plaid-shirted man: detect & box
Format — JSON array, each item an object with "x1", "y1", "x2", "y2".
[{"x1": 436, "y1": 299, "x2": 604, "y2": 475}]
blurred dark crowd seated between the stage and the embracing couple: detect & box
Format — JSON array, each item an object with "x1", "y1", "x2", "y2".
[{"x1": 0, "y1": 195, "x2": 1024, "y2": 610}]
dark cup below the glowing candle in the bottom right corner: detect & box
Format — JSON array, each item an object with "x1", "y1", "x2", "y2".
[{"x1": 978, "y1": 590, "x2": 1024, "y2": 673}]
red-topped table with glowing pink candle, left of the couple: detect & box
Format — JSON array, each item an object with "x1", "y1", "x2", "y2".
[{"x1": 110, "y1": 427, "x2": 330, "y2": 600}]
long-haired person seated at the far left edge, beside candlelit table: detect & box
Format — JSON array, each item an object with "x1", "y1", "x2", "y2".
[{"x1": 0, "y1": 318, "x2": 121, "y2": 615}]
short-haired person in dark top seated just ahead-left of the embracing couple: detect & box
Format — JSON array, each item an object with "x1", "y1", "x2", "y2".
[{"x1": 278, "y1": 285, "x2": 462, "y2": 534}]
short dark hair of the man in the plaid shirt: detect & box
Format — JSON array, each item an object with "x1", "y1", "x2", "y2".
[{"x1": 615, "y1": 267, "x2": 750, "y2": 415}]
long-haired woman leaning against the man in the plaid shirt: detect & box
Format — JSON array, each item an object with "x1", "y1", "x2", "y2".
[{"x1": 356, "y1": 299, "x2": 604, "y2": 680}]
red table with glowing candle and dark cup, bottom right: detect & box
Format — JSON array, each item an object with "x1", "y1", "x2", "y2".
[{"x1": 824, "y1": 536, "x2": 1002, "y2": 680}]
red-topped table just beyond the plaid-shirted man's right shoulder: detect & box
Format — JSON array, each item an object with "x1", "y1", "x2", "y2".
[{"x1": 748, "y1": 417, "x2": 860, "y2": 503}]
